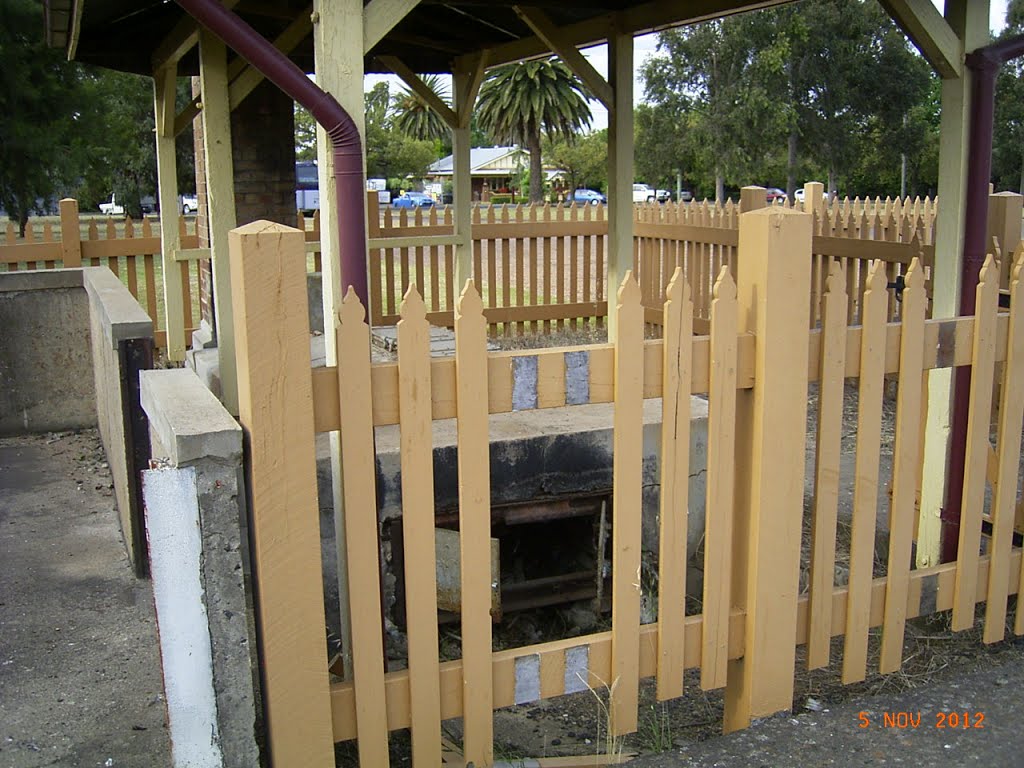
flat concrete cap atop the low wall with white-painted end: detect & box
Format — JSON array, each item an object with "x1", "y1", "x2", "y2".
[{"x1": 140, "y1": 369, "x2": 242, "y2": 467}]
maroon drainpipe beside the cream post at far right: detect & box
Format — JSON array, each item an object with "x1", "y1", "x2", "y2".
[{"x1": 940, "y1": 36, "x2": 1024, "y2": 562}]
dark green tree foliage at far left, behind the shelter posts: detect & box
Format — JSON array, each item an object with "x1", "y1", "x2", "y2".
[{"x1": 0, "y1": 0, "x2": 196, "y2": 228}]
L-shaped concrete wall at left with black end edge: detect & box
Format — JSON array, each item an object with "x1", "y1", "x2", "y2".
[{"x1": 0, "y1": 267, "x2": 153, "y2": 575}]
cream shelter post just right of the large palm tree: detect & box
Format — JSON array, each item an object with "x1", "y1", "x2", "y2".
[{"x1": 605, "y1": 30, "x2": 633, "y2": 339}]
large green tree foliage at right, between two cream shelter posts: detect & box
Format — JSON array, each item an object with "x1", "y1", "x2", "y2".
[{"x1": 637, "y1": 0, "x2": 937, "y2": 198}]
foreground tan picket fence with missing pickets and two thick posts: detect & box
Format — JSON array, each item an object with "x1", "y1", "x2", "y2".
[{"x1": 230, "y1": 210, "x2": 1024, "y2": 767}]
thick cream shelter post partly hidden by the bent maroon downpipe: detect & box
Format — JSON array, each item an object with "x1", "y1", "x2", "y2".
[{"x1": 313, "y1": 0, "x2": 376, "y2": 678}]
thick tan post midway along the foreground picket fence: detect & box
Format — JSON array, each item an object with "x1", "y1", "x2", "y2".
[{"x1": 725, "y1": 208, "x2": 811, "y2": 731}]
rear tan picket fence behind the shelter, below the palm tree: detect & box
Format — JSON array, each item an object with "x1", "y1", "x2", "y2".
[{"x1": 298, "y1": 187, "x2": 936, "y2": 336}]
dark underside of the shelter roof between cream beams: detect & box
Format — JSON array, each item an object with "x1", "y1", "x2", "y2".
[{"x1": 44, "y1": 0, "x2": 792, "y2": 75}]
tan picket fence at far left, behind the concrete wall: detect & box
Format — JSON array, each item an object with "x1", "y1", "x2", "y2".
[{"x1": 0, "y1": 200, "x2": 200, "y2": 347}]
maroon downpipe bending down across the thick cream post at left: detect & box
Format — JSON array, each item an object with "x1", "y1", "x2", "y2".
[{"x1": 176, "y1": 0, "x2": 370, "y2": 315}]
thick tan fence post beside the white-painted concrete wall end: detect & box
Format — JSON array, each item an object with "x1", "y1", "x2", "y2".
[{"x1": 229, "y1": 221, "x2": 331, "y2": 767}]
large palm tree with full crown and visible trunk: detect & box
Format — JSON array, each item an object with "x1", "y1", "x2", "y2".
[{"x1": 476, "y1": 58, "x2": 591, "y2": 203}]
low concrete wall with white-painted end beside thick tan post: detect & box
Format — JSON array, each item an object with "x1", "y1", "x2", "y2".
[{"x1": 141, "y1": 369, "x2": 260, "y2": 767}]
